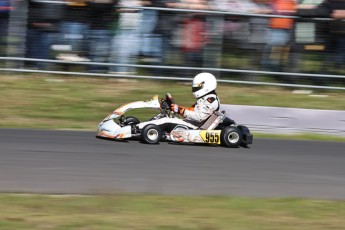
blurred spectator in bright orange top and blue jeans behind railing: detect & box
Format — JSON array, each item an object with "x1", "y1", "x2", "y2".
[{"x1": 257, "y1": 0, "x2": 296, "y2": 72}]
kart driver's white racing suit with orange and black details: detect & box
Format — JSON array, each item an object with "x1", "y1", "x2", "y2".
[{"x1": 171, "y1": 92, "x2": 220, "y2": 125}]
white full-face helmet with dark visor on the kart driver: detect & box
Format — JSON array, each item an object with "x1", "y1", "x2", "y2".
[{"x1": 192, "y1": 73, "x2": 217, "y2": 98}]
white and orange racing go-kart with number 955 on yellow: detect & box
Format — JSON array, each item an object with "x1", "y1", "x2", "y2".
[{"x1": 96, "y1": 94, "x2": 253, "y2": 147}]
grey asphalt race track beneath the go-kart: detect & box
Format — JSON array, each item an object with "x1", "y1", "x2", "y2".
[{"x1": 0, "y1": 129, "x2": 345, "y2": 199}]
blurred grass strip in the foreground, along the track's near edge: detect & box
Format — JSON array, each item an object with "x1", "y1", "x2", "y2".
[{"x1": 0, "y1": 194, "x2": 345, "y2": 230}]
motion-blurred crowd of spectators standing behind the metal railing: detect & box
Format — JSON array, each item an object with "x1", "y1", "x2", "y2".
[{"x1": 0, "y1": 0, "x2": 345, "y2": 77}]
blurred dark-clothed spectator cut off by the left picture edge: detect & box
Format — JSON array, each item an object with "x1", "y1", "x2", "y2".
[{"x1": 0, "y1": 0, "x2": 11, "y2": 56}]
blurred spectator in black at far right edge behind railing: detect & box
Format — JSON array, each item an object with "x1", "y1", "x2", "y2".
[{"x1": 297, "y1": 0, "x2": 345, "y2": 72}]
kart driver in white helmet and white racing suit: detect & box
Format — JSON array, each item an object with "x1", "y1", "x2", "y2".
[{"x1": 170, "y1": 73, "x2": 220, "y2": 125}]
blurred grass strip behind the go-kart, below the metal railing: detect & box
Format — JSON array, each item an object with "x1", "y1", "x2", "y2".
[{"x1": 0, "y1": 74, "x2": 345, "y2": 139}]
